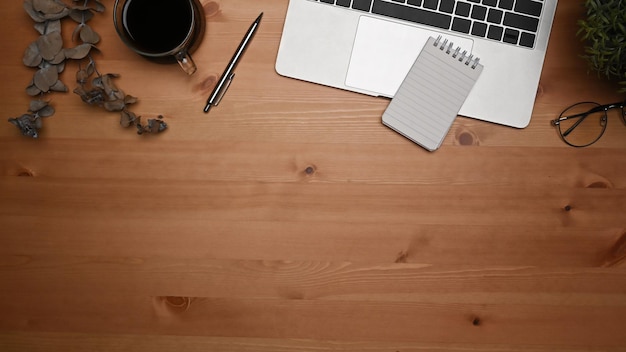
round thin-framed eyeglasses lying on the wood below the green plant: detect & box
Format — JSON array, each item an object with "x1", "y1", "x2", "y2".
[{"x1": 552, "y1": 100, "x2": 626, "y2": 147}]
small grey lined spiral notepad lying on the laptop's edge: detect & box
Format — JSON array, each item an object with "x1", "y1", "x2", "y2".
[{"x1": 383, "y1": 37, "x2": 483, "y2": 151}]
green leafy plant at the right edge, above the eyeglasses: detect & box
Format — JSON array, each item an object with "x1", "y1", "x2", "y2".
[{"x1": 578, "y1": 0, "x2": 626, "y2": 93}]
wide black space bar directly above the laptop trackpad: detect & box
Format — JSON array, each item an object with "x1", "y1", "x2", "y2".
[{"x1": 368, "y1": 0, "x2": 452, "y2": 29}]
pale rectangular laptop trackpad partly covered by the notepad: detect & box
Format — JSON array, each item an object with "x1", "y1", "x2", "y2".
[{"x1": 346, "y1": 16, "x2": 473, "y2": 97}]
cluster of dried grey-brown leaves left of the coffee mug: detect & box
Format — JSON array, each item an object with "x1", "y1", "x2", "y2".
[{"x1": 9, "y1": 0, "x2": 167, "y2": 138}]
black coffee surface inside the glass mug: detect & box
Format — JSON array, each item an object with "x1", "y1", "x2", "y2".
[{"x1": 122, "y1": 0, "x2": 193, "y2": 54}]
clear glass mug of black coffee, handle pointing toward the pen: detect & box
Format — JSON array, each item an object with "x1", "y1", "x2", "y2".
[{"x1": 113, "y1": 0, "x2": 205, "y2": 75}]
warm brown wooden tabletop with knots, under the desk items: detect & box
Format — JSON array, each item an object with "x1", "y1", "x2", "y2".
[{"x1": 0, "y1": 0, "x2": 626, "y2": 352}]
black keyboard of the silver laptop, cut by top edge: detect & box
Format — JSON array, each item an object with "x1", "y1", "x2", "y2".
[{"x1": 311, "y1": 0, "x2": 547, "y2": 48}]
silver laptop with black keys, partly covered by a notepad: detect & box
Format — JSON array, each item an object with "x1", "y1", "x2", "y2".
[{"x1": 276, "y1": 0, "x2": 557, "y2": 128}]
